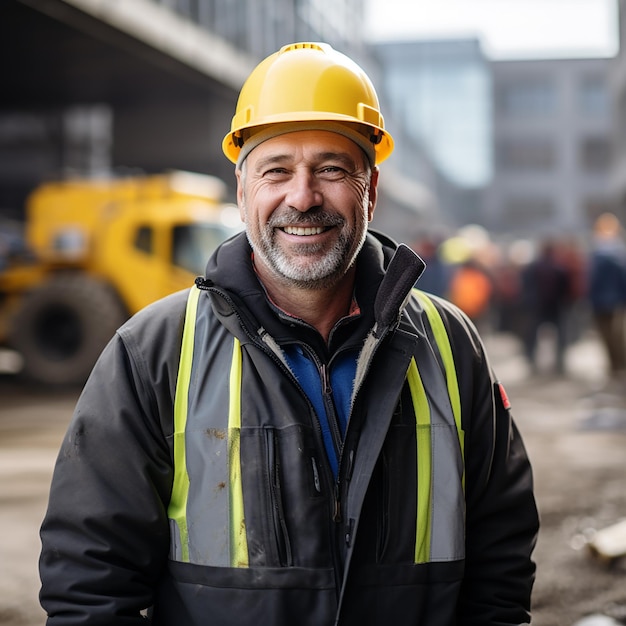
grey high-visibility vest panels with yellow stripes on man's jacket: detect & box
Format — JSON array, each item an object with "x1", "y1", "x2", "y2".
[{"x1": 168, "y1": 287, "x2": 465, "y2": 567}]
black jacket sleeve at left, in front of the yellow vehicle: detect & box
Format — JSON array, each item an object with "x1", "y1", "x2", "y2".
[{"x1": 40, "y1": 294, "x2": 180, "y2": 626}]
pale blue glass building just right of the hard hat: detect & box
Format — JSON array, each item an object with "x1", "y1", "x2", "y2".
[{"x1": 374, "y1": 39, "x2": 492, "y2": 224}]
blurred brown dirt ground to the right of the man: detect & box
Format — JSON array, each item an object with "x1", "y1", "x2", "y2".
[{"x1": 487, "y1": 337, "x2": 626, "y2": 626}]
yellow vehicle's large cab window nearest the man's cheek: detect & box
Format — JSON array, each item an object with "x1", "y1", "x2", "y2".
[{"x1": 172, "y1": 224, "x2": 233, "y2": 274}]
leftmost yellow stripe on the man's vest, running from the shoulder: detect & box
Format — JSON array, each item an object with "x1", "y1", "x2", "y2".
[{"x1": 168, "y1": 287, "x2": 200, "y2": 562}]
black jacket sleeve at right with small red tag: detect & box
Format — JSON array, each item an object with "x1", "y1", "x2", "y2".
[{"x1": 438, "y1": 302, "x2": 539, "y2": 626}]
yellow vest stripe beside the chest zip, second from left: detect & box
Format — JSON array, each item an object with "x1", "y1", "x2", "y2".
[{"x1": 228, "y1": 338, "x2": 248, "y2": 567}]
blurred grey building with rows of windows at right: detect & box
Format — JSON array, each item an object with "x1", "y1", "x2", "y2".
[{"x1": 483, "y1": 59, "x2": 608, "y2": 237}]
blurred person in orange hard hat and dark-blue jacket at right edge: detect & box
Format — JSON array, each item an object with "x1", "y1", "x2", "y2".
[{"x1": 589, "y1": 213, "x2": 626, "y2": 382}]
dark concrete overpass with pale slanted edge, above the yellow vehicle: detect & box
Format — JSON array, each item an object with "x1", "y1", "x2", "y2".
[{"x1": 0, "y1": 0, "x2": 257, "y2": 214}]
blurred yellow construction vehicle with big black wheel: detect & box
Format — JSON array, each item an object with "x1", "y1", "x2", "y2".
[{"x1": 0, "y1": 172, "x2": 241, "y2": 385}]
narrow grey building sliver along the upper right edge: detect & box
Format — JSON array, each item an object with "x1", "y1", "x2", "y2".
[{"x1": 610, "y1": 0, "x2": 626, "y2": 219}]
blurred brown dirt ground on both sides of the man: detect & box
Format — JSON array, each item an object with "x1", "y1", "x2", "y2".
[{"x1": 0, "y1": 336, "x2": 626, "y2": 626}]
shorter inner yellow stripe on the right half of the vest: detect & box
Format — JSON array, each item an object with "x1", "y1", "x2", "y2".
[{"x1": 407, "y1": 358, "x2": 432, "y2": 563}]
